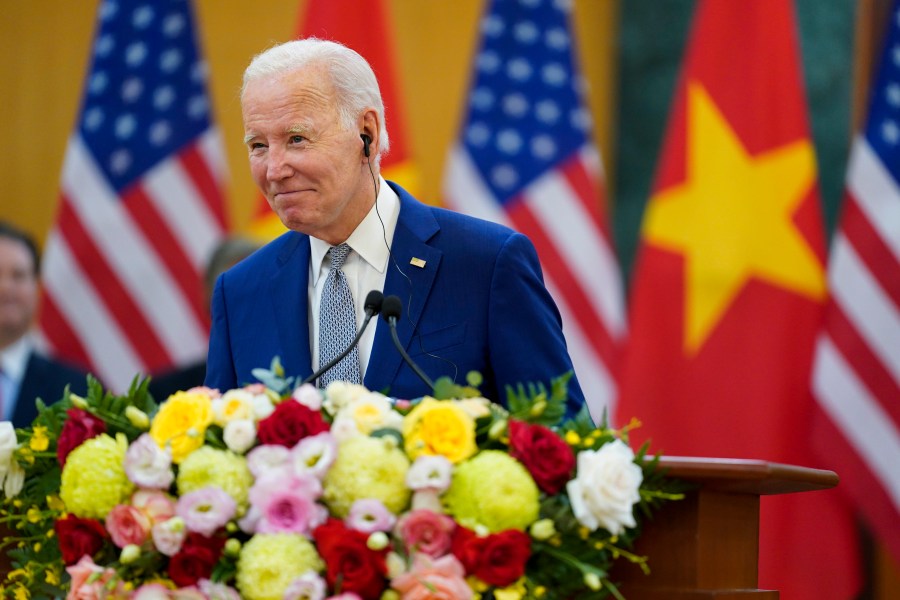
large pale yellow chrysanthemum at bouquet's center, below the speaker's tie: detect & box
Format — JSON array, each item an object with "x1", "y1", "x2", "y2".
[{"x1": 323, "y1": 436, "x2": 410, "y2": 519}]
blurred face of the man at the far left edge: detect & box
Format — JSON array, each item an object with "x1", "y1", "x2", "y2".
[{"x1": 0, "y1": 237, "x2": 38, "y2": 348}]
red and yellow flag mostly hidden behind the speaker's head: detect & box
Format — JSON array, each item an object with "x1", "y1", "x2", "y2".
[{"x1": 250, "y1": 0, "x2": 419, "y2": 239}]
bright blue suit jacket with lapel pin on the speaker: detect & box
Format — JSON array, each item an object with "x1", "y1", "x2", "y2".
[{"x1": 206, "y1": 183, "x2": 584, "y2": 416}]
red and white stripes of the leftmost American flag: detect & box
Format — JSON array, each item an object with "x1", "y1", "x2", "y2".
[{"x1": 41, "y1": 129, "x2": 225, "y2": 392}]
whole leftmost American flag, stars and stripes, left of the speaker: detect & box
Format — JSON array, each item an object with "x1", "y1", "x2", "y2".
[{"x1": 40, "y1": 0, "x2": 226, "y2": 391}]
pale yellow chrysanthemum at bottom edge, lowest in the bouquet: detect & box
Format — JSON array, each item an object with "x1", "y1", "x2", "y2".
[{"x1": 237, "y1": 533, "x2": 325, "y2": 600}]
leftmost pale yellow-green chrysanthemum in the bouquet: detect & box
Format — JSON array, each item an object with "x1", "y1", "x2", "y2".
[{"x1": 59, "y1": 433, "x2": 134, "y2": 519}]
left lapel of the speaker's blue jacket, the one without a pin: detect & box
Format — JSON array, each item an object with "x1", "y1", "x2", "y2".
[{"x1": 269, "y1": 233, "x2": 312, "y2": 379}]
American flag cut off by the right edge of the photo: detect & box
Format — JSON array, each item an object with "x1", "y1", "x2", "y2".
[{"x1": 813, "y1": 2, "x2": 900, "y2": 559}]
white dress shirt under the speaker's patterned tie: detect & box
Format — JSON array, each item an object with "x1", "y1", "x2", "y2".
[{"x1": 308, "y1": 176, "x2": 400, "y2": 379}]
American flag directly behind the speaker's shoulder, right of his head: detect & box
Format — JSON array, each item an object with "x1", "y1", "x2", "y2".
[{"x1": 444, "y1": 0, "x2": 626, "y2": 419}]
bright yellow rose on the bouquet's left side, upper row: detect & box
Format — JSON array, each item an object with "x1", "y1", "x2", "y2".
[{"x1": 150, "y1": 392, "x2": 213, "y2": 464}]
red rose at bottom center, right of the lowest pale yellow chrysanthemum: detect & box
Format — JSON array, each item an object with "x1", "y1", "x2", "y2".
[{"x1": 313, "y1": 519, "x2": 387, "y2": 600}]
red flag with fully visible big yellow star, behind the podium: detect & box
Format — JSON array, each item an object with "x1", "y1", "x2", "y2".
[{"x1": 617, "y1": 0, "x2": 860, "y2": 600}]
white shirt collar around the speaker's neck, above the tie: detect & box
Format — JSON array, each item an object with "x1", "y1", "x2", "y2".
[{"x1": 309, "y1": 176, "x2": 400, "y2": 286}]
